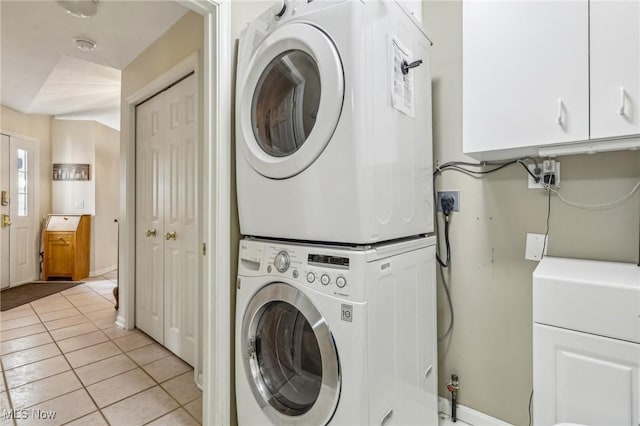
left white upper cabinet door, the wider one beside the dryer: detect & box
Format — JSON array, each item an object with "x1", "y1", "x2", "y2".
[{"x1": 463, "y1": 0, "x2": 589, "y2": 158}]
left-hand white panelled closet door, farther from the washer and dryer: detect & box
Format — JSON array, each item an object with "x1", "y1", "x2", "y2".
[{"x1": 136, "y1": 96, "x2": 164, "y2": 343}]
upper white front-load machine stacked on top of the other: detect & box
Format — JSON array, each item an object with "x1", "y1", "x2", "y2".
[{"x1": 236, "y1": 0, "x2": 433, "y2": 244}]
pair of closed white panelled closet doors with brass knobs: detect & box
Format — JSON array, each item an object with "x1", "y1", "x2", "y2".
[{"x1": 136, "y1": 75, "x2": 200, "y2": 365}]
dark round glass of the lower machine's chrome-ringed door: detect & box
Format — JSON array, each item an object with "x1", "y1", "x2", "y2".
[{"x1": 255, "y1": 302, "x2": 322, "y2": 416}]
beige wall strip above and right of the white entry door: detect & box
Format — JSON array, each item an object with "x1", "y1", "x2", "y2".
[{"x1": 0, "y1": 106, "x2": 51, "y2": 223}]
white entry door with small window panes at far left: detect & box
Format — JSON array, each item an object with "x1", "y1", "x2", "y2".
[{"x1": 0, "y1": 135, "x2": 39, "y2": 288}]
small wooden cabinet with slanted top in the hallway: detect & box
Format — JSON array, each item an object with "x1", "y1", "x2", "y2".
[{"x1": 43, "y1": 215, "x2": 91, "y2": 281}]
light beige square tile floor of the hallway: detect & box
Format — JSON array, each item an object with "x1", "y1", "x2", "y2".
[{"x1": 0, "y1": 272, "x2": 202, "y2": 426}]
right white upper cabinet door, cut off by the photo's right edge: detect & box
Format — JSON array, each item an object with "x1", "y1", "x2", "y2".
[{"x1": 589, "y1": 0, "x2": 640, "y2": 139}]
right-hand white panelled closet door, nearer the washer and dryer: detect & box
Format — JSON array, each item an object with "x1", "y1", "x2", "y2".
[{"x1": 164, "y1": 75, "x2": 200, "y2": 365}]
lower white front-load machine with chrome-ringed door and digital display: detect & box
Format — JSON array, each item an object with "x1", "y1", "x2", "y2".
[{"x1": 236, "y1": 237, "x2": 438, "y2": 426}]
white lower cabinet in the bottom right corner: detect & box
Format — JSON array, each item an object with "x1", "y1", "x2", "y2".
[{"x1": 533, "y1": 257, "x2": 640, "y2": 426}]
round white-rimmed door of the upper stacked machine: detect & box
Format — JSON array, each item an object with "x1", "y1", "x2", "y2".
[{"x1": 236, "y1": 23, "x2": 344, "y2": 179}]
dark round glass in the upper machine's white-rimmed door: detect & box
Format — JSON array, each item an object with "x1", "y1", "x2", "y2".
[{"x1": 251, "y1": 50, "x2": 321, "y2": 157}]
